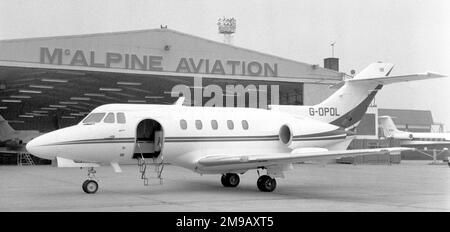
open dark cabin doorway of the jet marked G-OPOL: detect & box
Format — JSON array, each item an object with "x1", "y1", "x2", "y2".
[{"x1": 133, "y1": 119, "x2": 164, "y2": 159}]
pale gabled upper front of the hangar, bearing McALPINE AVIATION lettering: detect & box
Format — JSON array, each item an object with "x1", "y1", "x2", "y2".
[{"x1": 0, "y1": 29, "x2": 345, "y2": 84}]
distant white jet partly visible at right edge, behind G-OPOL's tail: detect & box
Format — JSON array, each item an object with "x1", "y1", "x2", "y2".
[{"x1": 378, "y1": 116, "x2": 450, "y2": 146}]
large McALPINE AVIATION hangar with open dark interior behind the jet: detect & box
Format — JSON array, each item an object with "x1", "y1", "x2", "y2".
[{"x1": 0, "y1": 28, "x2": 344, "y2": 132}]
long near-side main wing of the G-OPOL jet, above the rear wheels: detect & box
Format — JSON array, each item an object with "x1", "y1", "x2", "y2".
[{"x1": 198, "y1": 147, "x2": 414, "y2": 169}]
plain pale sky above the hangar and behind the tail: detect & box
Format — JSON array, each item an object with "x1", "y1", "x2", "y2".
[{"x1": 0, "y1": 0, "x2": 450, "y2": 131}]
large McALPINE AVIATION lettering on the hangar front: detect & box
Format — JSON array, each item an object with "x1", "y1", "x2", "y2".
[{"x1": 39, "y1": 47, "x2": 278, "y2": 77}]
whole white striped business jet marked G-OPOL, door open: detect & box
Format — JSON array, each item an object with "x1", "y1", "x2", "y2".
[{"x1": 27, "y1": 63, "x2": 443, "y2": 193}]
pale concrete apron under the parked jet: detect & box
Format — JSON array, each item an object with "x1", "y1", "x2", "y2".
[{"x1": 0, "y1": 161, "x2": 450, "y2": 211}]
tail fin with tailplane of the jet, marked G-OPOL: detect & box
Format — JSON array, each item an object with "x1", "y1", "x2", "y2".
[{"x1": 270, "y1": 63, "x2": 444, "y2": 128}]
